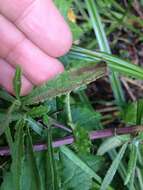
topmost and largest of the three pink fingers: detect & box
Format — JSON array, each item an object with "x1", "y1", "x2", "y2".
[{"x1": 0, "y1": 0, "x2": 72, "y2": 57}]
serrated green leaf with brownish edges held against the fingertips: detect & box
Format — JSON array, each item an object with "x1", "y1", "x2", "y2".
[{"x1": 23, "y1": 64, "x2": 106, "y2": 105}]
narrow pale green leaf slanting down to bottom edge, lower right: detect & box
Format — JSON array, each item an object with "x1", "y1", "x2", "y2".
[{"x1": 100, "y1": 143, "x2": 128, "y2": 190}]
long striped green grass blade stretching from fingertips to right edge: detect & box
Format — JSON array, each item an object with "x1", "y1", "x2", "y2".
[{"x1": 69, "y1": 47, "x2": 143, "y2": 79}]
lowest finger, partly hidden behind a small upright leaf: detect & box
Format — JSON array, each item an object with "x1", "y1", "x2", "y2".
[{"x1": 0, "y1": 59, "x2": 32, "y2": 95}]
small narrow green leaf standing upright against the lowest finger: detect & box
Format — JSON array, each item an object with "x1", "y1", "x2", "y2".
[{"x1": 13, "y1": 66, "x2": 22, "y2": 99}]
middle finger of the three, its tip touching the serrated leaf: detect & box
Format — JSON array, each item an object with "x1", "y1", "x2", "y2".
[{"x1": 0, "y1": 16, "x2": 64, "y2": 85}]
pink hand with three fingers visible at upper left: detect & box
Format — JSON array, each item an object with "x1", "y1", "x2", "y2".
[{"x1": 0, "y1": 0, "x2": 72, "y2": 95}]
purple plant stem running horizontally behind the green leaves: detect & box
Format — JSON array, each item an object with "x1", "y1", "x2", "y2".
[{"x1": 0, "y1": 125, "x2": 143, "y2": 156}]
